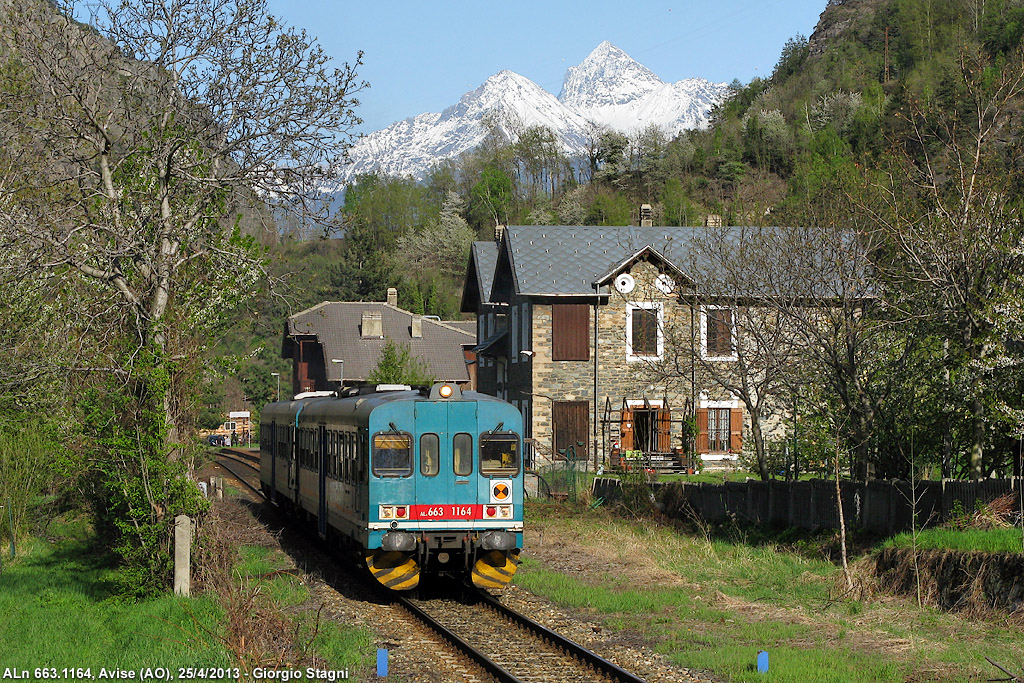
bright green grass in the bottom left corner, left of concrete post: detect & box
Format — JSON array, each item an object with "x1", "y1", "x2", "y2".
[{"x1": 0, "y1": 535, "x2": 228, "y2": 674}]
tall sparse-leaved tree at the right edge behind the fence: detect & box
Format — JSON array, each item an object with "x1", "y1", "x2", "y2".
[{"x1": 858, "y1": 53, "x2": 1024, "y2": 479}]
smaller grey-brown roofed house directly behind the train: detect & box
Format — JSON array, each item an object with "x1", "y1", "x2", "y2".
[{"x1": 282, "y1": 292, "x2": 476, "y2": 393}]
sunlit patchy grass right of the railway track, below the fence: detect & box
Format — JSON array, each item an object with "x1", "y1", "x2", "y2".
[{"x1": 515, "y1": 501, "x2": 1024, "y2": 683}]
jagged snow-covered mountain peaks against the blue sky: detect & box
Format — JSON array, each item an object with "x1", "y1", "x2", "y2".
[{"x1": 344, "y1": 41, "x2": 728, "y2": 182}]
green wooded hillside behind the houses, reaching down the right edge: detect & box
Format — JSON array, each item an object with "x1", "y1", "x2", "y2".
[{"x1": 236, "y1": 0, "x2": 1024, "y2": 483}]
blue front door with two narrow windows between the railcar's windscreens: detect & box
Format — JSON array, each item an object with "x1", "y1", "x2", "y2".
[{"x1": 415, "y1": 401, "x2": 479, "y2": 511}]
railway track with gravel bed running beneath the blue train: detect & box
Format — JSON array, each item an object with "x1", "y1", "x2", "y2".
[{"x1": 205, "y1": 449, "x2": 644, "y2": 683}]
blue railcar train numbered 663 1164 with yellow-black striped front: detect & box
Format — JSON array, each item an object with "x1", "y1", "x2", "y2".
[{"x1": 260, "y1": 384, "x2": 523, "y2": 590}]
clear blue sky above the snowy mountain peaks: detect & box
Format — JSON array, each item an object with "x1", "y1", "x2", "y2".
[{"x1": 269, "y1": 0, "x2": 826, "y2": 133}]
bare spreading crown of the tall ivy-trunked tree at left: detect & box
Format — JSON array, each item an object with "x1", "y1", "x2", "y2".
[{"x1": 0, "y1": 0, "x2": 365, "y2": 440}]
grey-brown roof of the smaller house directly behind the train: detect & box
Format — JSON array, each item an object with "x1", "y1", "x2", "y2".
[{"x1": 284, "y1": 301, "x2": 476, "y2": 382}]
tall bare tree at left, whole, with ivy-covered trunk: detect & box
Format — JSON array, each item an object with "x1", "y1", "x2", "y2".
[{"x1": 0, "y1": 0, "x2": 365, "y2": 595}]
